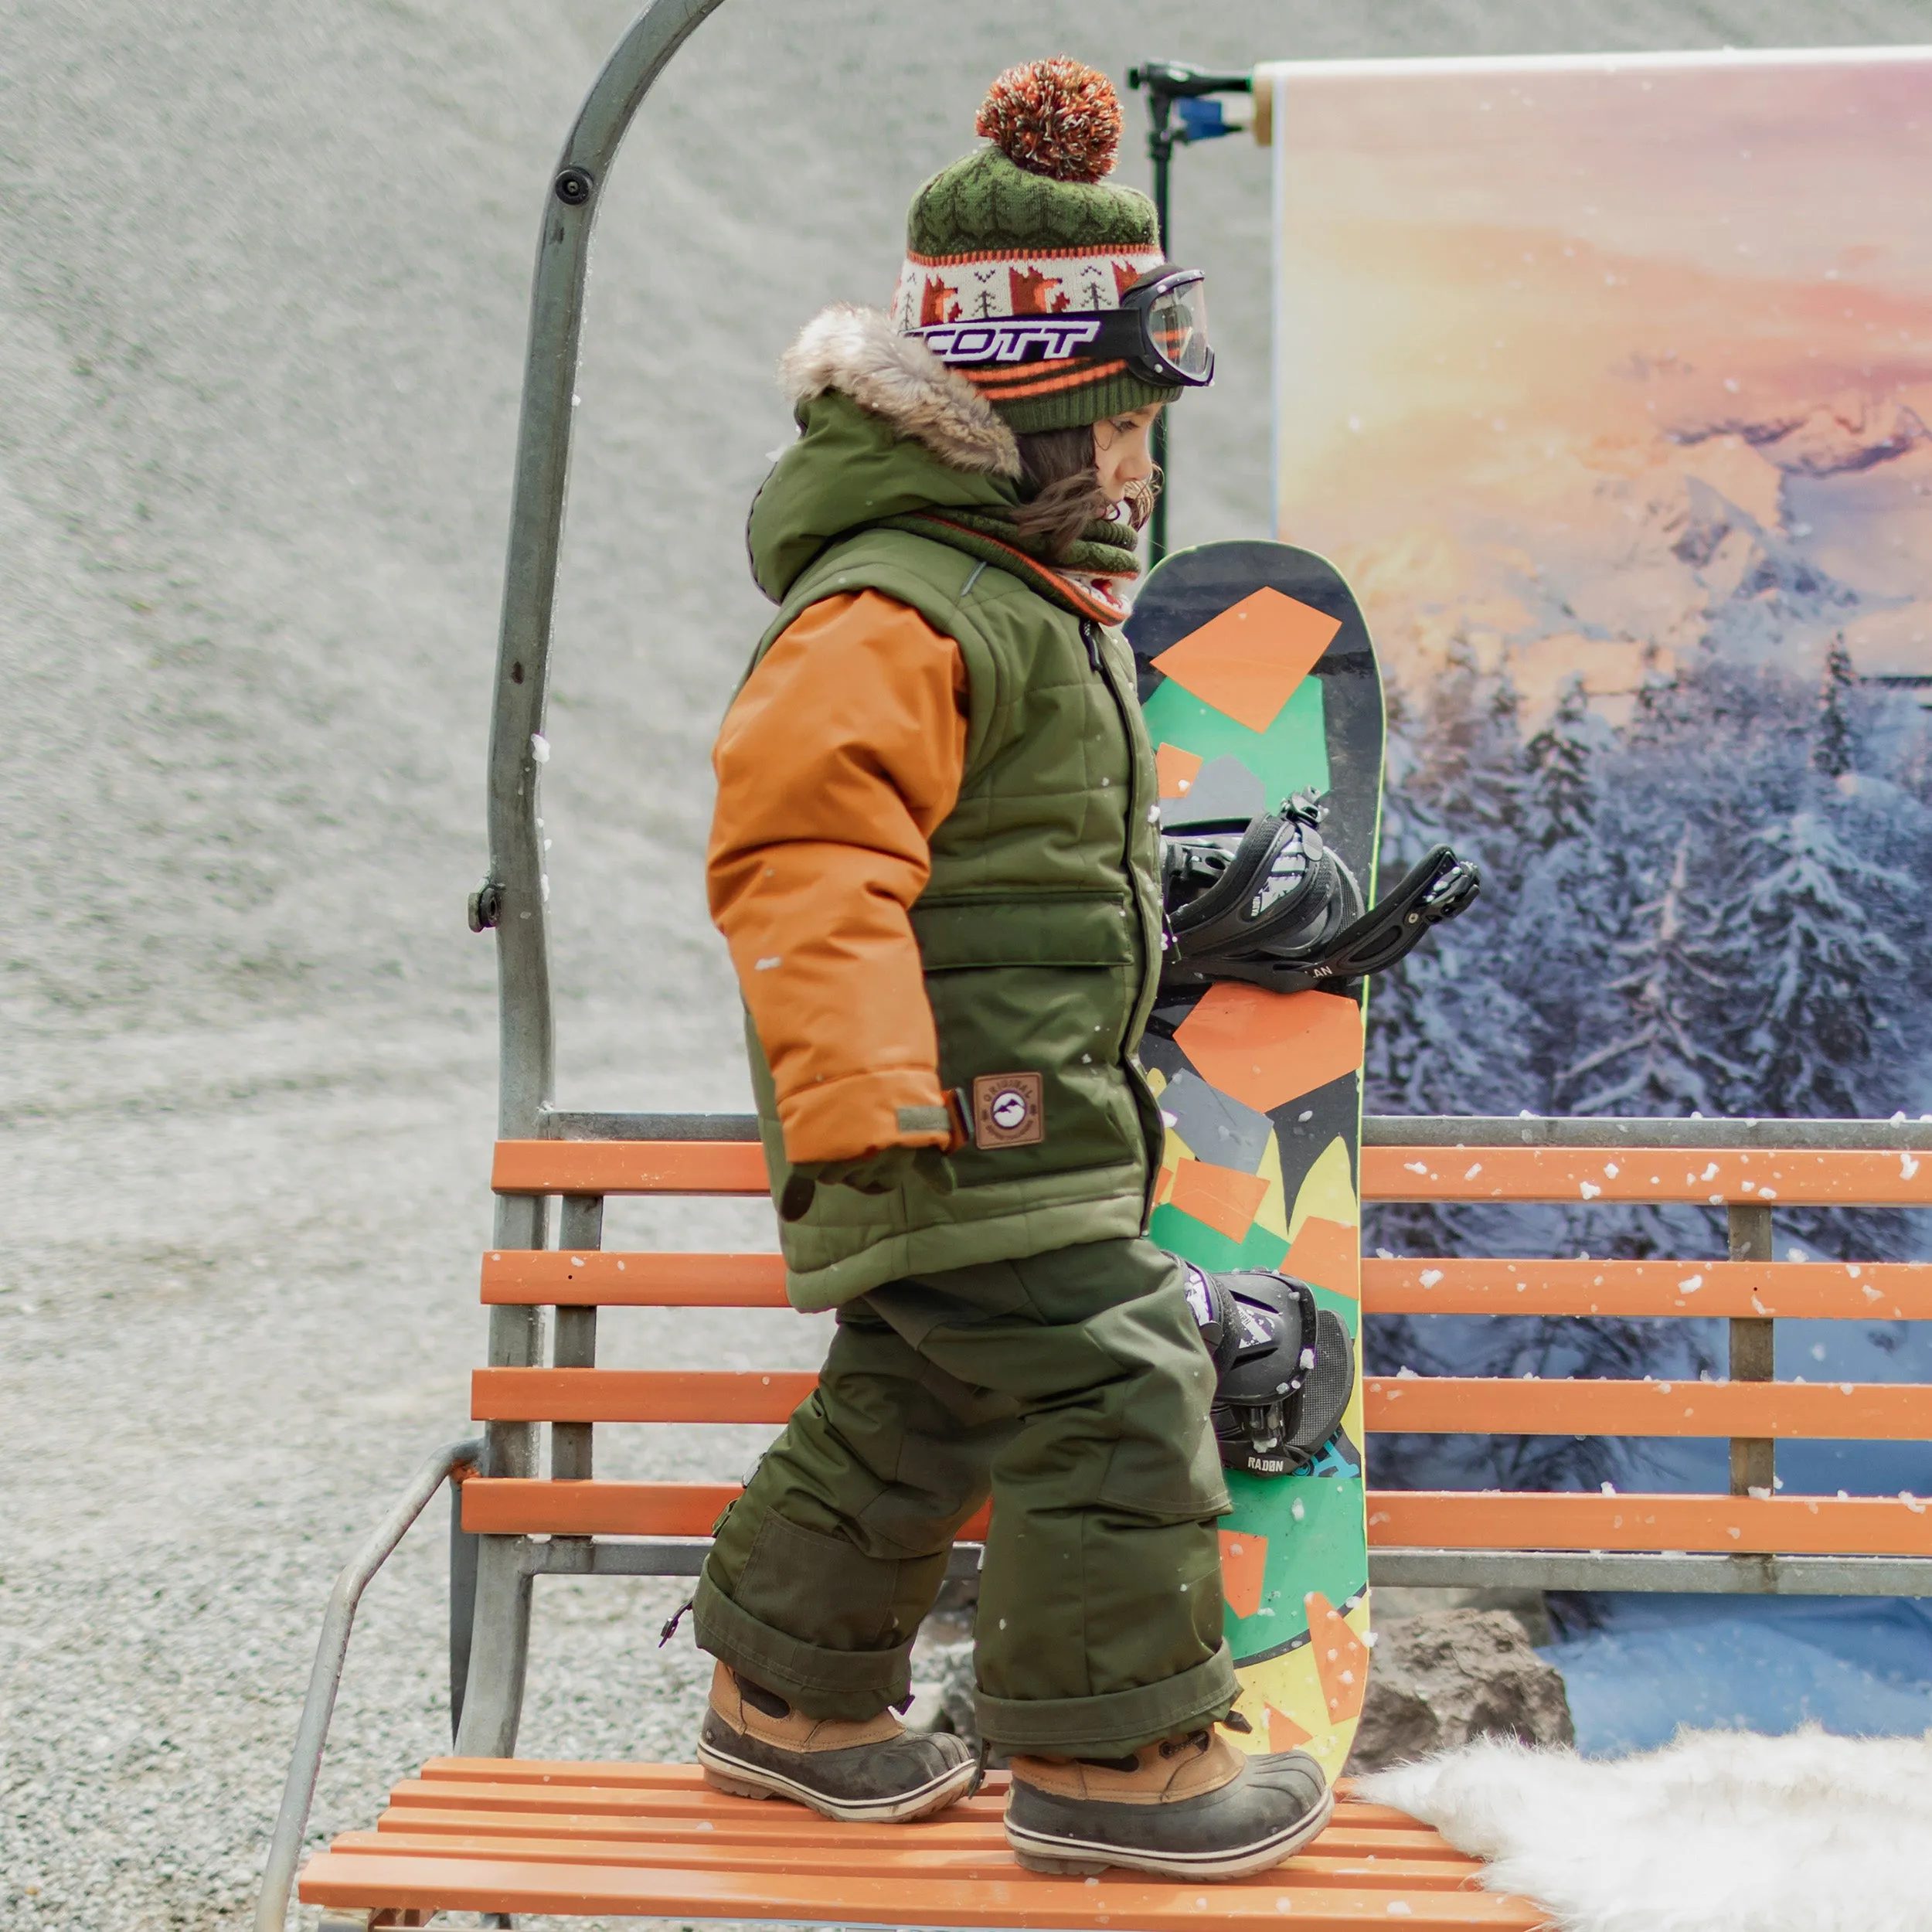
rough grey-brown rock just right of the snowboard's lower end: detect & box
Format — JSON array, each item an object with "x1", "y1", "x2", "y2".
[{"x1": 1349, "y1": 1610, "x2": 1577, "y2": 1772}]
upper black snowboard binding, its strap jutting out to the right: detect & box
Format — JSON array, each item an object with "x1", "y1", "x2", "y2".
[{"x1": 1162, "y1": 792, "x2": 1482, "y2": 993}]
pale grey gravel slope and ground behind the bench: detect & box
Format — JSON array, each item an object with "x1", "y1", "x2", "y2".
[{"x1": 11, "y1": 0, "x2": 1927, "y2": 1932}]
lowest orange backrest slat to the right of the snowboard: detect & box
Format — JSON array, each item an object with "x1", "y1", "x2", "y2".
[{"x1": 1368, "y1": 1490, "x2": 1932, "y2": 1557}]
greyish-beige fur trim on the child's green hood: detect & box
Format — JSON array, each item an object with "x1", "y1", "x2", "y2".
[{"x1": 779, "y1": 301, "x2": 1020, "y2": 478}]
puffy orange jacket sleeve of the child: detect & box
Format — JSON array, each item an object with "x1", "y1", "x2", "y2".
[{"x1": 706, "y1": 591, "x2": 966, "y2": 1162}]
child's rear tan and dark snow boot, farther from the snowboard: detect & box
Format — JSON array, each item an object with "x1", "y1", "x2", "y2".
[{"x1": 698, "y1": 1664, "x2": 978, "y2": 1824}]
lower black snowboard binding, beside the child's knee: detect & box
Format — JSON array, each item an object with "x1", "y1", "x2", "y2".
[{"x1": 1182, "y1": 1262, "x2": 1355, "y2": 1476}]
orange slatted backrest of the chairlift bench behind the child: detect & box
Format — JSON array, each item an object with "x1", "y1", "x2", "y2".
[{"x1": 464, "y1": 1123, "x2": 1932, "y2": 1557}]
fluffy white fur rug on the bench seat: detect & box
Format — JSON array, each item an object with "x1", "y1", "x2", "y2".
[{"x1": 1356, "y1": 1730, "x2": 1932, "y2": 1932}]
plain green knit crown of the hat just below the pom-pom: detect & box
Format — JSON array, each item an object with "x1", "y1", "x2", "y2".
[{"x1": 906, "y1": 147, "x2": 1162, "y2": 255}]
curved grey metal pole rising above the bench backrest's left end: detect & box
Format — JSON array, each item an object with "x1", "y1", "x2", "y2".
[{"x1": 474, "y1": 0, "x2": 723, "y2": 1144}]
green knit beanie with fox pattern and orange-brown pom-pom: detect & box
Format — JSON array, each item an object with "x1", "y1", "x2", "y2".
[{"x1": 893, "y1": 56, "x2": 1181, "y2": 435}]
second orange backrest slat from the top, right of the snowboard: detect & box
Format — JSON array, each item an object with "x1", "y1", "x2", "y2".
[{"x1": 1362, "y1": 1256, "x2": 1932, "y2": 1321}]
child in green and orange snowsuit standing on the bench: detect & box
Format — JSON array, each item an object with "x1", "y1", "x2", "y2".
[{"x1": 696, "y1": 60, "x2": 1332, "y2": 1878}]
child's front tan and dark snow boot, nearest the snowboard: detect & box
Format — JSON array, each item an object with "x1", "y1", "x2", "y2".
[{"x1": 1007, "y1": 1731, "x2": 1335, "y2": 1878}]
